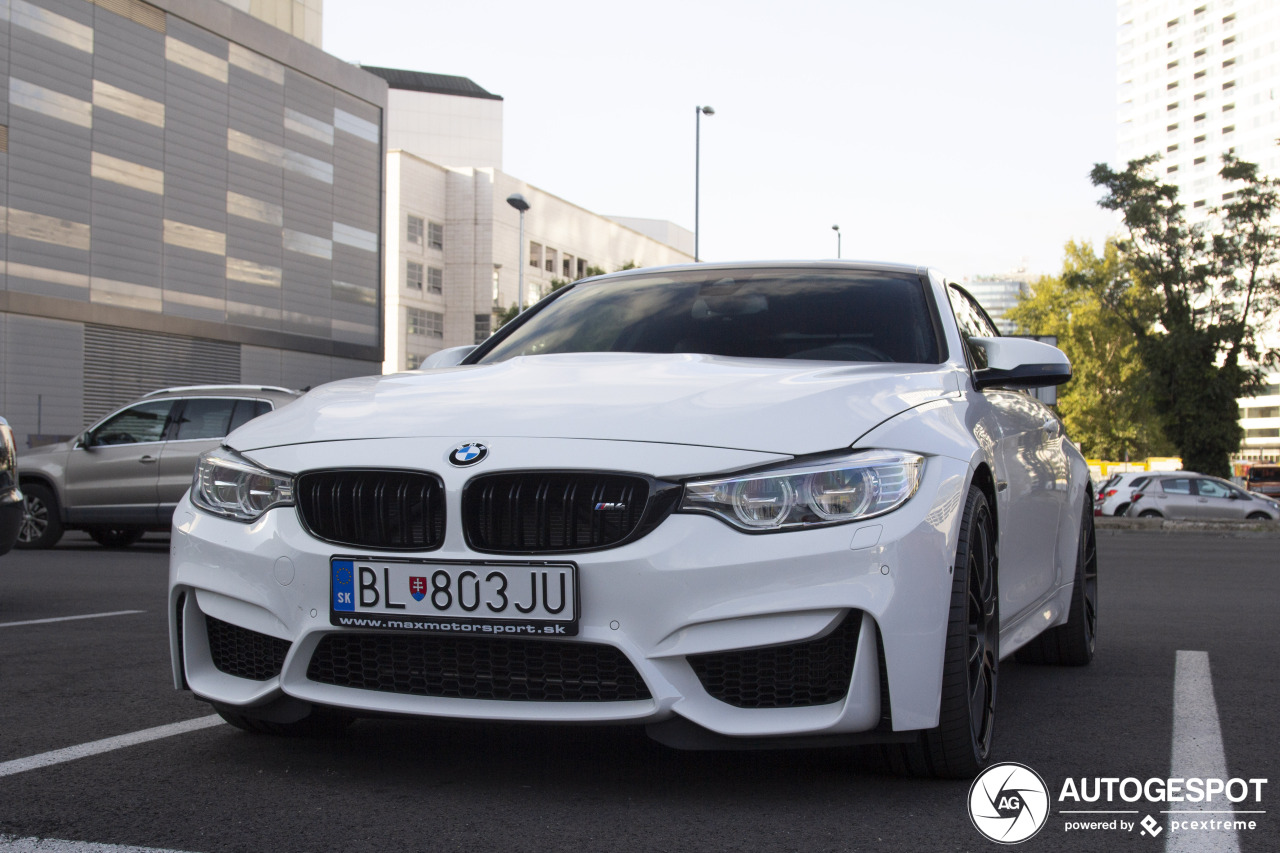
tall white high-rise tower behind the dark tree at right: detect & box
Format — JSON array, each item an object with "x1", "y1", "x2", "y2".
[{"x1": 1116, "y1": 0, "x2": 1280, "y2": 461}]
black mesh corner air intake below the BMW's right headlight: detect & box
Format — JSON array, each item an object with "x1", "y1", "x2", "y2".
[{"x1": 687, "y1": 611, "x2": 863, "y2": 708}]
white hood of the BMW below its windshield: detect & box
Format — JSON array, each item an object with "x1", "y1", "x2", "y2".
[{"x1": 227, "y1": 353, "x2": 957, "y2": 455}]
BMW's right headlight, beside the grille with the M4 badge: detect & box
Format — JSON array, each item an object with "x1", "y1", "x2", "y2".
[{"x1": 680, "y1": 451, "x2": 924, "y2": 532}]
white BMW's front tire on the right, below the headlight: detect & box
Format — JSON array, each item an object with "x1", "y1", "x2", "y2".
[{"x1": 884, "y1": 485, "x2": 1000, "y2": 779}]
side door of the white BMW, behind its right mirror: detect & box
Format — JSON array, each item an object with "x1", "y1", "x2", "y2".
[{"x1": 948, "y1": 286, "x2": 1064, "y2": 619}]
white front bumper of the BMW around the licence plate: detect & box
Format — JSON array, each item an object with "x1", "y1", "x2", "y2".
[{"x1": 169, "y1": 445, "x2": 968, "y2": 738}]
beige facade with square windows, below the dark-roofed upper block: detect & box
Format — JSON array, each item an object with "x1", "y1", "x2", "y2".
[{"x1": 383, "y1": 151, "x2": 692, "y2": 373}]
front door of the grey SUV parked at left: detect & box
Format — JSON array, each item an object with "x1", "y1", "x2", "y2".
[{"x1": 63, "y1": 400, "x2": 173, "y2": 524}]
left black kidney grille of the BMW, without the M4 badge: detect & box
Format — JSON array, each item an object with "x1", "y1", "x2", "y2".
[{"x1": 296, "y1": 470, "x2": 444, "y2": 551}]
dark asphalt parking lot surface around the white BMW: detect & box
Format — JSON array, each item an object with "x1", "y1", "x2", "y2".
[{"x1": 0, "y1": 532, "x2": 1280, "y2": 853}]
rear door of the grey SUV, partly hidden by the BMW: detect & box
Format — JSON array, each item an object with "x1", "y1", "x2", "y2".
[{"x1": 156, "y1": 397, "x2": 271, "y2": 523}]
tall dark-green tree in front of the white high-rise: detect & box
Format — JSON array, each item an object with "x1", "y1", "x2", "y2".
[{"x1": 1068, "y1": 155, "x2": 1280, "y2": 476}]
